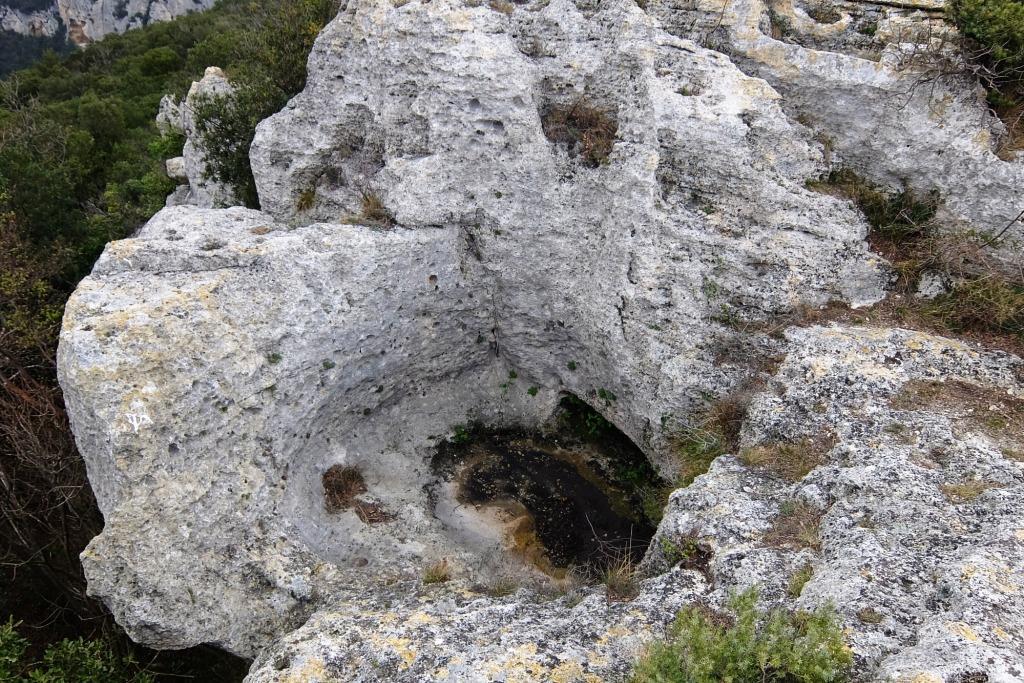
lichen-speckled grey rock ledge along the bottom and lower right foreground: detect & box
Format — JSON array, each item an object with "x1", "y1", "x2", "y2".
[{"x1": 247, "y1": 328, "x2": 1024, "y2": 683}]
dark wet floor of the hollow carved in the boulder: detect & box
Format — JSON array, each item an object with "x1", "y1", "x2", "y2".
[{"x1": 433, "y1": 395, "x2": 665, "y2": 579}]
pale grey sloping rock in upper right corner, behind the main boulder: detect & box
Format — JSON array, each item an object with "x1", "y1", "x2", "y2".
[{"x1": 647, "y1": 0, "x2": 1024, "y2": 237}]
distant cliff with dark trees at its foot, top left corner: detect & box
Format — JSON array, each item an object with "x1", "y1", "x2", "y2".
[{"x1": 0, "y1": 0, "x2": 216, "y2": 74}]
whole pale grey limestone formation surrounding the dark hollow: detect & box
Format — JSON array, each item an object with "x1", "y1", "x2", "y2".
[{"x1": 58, "y1": 0, "x2": 1024, "y2": 682}]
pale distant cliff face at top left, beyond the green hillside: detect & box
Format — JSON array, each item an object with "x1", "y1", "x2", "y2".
[{"x1": 0, "y1": 0, "x2": 214, "y2": 46}]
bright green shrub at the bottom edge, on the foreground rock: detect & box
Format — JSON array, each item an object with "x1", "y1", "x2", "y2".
[{"x1": 632, "y1": 589, "x2": 853, "y2": 683}]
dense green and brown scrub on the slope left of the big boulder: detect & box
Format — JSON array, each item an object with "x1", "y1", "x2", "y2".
[{"x1": 0, "y1": 0, "x2": 333, "y2": 680}]
